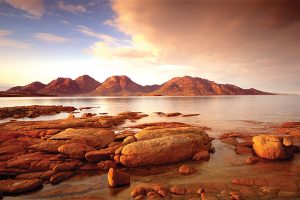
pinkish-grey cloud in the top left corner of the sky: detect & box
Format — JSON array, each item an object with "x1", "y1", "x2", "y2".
[{"x1": 3, "y1": 0, "x2": 45, "y2": 18}]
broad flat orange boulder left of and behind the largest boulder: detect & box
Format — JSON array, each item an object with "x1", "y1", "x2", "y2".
[{"x1": 49, "y1": 128, "x2": 116, "y2": 148}]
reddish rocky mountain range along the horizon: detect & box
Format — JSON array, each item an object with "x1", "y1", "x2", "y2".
[{"x1": 2, "y1": 75, "x2": 271, "y2": 96}]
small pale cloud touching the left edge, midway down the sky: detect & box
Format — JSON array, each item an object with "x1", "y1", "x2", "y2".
[{"x1": 0, "y1": 29, "x2": 30, "y2": 49}]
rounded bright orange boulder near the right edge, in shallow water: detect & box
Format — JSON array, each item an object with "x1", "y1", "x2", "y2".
[{"x1": 253, "y1": 135, "x2": 293, "y2": 160}]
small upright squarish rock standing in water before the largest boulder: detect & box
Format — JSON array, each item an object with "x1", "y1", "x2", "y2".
[{"x1": 108, "y1": 168, "x2": 130, "y2": 187}]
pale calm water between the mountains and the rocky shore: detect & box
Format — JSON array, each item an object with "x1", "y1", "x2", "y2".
[{"x1": 0, "y1": 95, "x2": 300, "y2": 134}]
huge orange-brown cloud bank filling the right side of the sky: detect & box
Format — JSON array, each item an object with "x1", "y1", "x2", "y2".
[{"x1": 105, "y1": 0, "x2": 300, "y2": 92}]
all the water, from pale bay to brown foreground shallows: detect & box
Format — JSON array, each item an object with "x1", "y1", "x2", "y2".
[{"x1": 0, "y1": 95, "x2": 300, "y2": 199}]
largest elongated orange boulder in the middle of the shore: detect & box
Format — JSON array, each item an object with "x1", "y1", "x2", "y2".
[{"x1": 117, "y1": 128, "x2": 211, "y2": 167}]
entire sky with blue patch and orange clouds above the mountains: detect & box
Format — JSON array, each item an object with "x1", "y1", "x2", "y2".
[{"x1": 0, "y1": 0, "x2": 300, "y2": 94}]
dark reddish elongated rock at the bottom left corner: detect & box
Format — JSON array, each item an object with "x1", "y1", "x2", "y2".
[{"x1": 0, "y1": 179, "x2": 43, "y2": 194}]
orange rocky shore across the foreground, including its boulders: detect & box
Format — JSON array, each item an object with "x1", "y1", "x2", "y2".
[{"x1": 0, "y1": 112, "x2": 300, "y2": 200}]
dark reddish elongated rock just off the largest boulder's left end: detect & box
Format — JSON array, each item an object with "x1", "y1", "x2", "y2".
[{"x1": 85, "y1": 145, "x2": 121, "y2": 162}]
